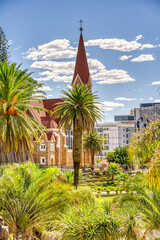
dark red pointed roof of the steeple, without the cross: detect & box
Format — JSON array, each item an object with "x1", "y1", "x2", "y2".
[{"x1": 72, "y1": 31, "x2": 90, "y2": 85}]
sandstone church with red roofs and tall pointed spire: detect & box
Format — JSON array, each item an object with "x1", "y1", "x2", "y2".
[{"x1": 28, "y1": 27, "x2": 92, "y2": 167}]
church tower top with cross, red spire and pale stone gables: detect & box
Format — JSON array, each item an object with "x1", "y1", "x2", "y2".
[{"x1": 72, "y1": 21, "x2": 92, "y2": 87}]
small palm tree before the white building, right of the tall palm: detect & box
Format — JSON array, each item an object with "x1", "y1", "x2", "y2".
[{"x1": 83, "y1": 129, "x2": 103, "y2": 169}]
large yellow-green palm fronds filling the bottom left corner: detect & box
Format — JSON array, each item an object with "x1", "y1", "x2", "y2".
[{"x1": 0, "y1": 163, "x2": 71, "y2": 240}]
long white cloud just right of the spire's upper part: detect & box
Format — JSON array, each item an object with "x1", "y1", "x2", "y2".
[{"x1": 85, "y1": 38, "x2": 142, "y2": 52}]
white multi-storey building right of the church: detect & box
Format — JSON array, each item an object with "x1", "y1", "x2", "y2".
[{"x1": 95, "y1": 122, "x2": 134, "y2": 158}]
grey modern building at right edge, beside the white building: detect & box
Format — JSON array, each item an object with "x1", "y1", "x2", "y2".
[{"x1": 134, "y1": 103, "x2": 160, "y2": 132}]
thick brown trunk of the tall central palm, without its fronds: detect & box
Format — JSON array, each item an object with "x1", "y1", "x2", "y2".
[{"x1": 73, "y1": 121, "x2": 82, "y2": 188}]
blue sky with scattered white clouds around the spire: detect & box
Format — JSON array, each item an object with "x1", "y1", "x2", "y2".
[{"x1": 0, "y1": 0, "x2": 160, "y2": 121}]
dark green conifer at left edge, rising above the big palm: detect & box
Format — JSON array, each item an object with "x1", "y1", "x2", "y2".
[{"x1": 0, "y1": 27, "x2": 9, "y2": 62}]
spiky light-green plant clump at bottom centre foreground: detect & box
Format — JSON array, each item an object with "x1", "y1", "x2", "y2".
[{"x1": 60, "y1": 201, "x2": 122, "y2": 240}]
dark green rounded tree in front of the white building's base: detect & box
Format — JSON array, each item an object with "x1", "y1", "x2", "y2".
[{"x1": 106, "y1": 146, "x2": 130, "y2": 166}]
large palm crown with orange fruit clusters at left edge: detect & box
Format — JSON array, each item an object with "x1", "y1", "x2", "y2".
[{"x1": 0, "y1": 62, "x2": 47, "y2": 161}]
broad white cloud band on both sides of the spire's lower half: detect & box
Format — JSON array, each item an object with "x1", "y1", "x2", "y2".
[{"x1": 31, "y1": 59, "x2": 135, "y2": 84}]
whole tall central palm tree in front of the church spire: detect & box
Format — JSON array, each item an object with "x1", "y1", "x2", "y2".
[{"x1": 53, "y1": 84, "x2": 101, "y2": 188}]
